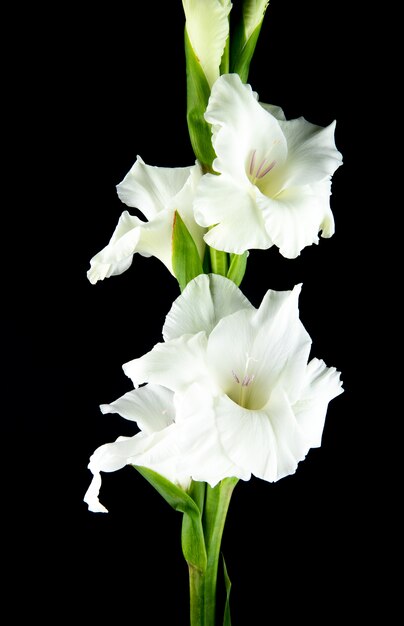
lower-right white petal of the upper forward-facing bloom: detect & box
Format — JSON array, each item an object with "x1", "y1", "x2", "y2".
[{"x1": 257, "y1": 180, "x2": 334, "y2": 259}]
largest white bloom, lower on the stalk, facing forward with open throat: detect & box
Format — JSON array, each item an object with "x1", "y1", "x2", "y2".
[{"x1": 124, "y1": 274, "x2": 342, "y2": 486}]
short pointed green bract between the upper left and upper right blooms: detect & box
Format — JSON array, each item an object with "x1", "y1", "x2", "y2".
[{"x1": 172, "y1": 211, "x2": 203, "y2": 291}]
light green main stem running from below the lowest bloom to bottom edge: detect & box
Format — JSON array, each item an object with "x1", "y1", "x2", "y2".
[{"x1": 204, "y1": 478, "x2": 238, "y2": 626}]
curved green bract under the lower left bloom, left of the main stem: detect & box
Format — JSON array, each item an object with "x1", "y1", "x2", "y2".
[{"x1": 133, "y1": 465, "x2": 207, "y2": 572}]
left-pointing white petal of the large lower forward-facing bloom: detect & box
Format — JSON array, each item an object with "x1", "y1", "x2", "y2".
[{"x1": 123, "y1": 332, "x2": 213, "y2": 392}]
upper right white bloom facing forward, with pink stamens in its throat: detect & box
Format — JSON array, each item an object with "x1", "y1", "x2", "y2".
[{"x1": 194, "y1": 74, "x2": 342, "y2": 258}]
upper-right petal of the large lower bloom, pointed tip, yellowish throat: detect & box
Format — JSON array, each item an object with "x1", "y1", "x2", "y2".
[{"x1": 207, "y1": 286, "x2": 311, "y2": 410}]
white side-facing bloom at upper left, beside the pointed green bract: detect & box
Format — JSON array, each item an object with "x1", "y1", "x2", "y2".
[{"x1": 87, "y1": 156, "x2": 206, "y2": 284}]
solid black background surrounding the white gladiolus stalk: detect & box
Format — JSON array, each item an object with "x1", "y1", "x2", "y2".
[{"x1": 2, "y1": 0, "x2": 383, "y2": 626}]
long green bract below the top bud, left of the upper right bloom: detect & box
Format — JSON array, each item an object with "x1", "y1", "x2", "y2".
[{"x1": 185, "y1": 29, "x2": 216, "y2": 171}]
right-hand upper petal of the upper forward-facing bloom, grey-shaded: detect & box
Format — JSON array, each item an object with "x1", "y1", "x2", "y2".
[{"x1": 280, "y1": 117, "x2": 342, "y2": 187}]
